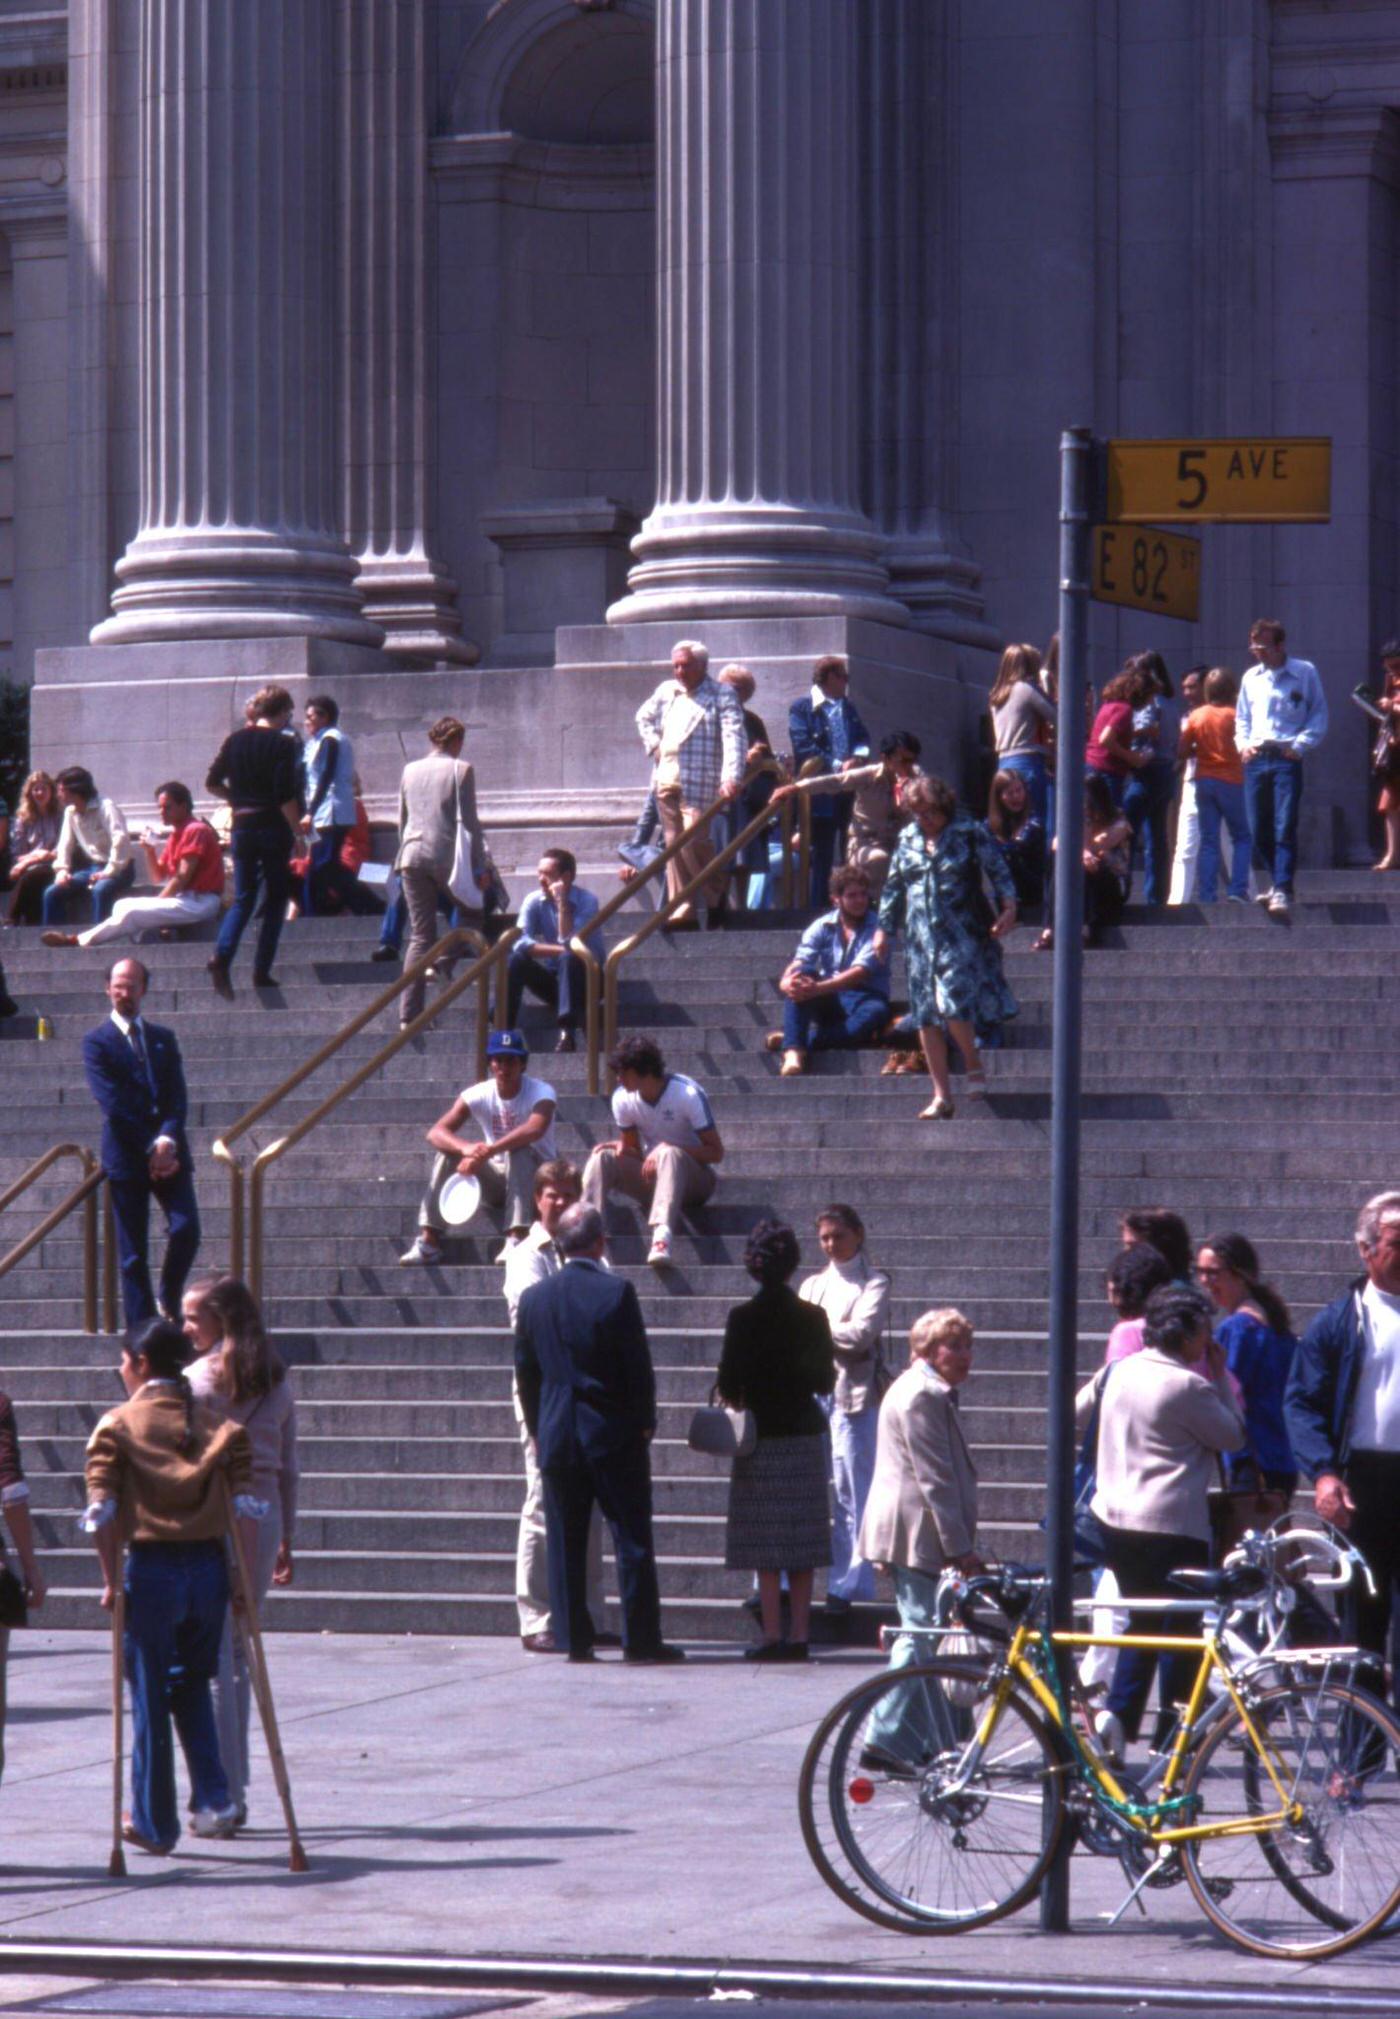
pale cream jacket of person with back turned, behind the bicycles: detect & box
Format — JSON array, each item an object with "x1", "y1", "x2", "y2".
[{"x1": 1075, "y1": 1347, "x2": 1244, "y2": 1543}]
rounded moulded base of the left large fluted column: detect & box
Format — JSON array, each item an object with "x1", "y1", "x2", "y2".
[{"x1": 91, "y1": 527, "x2": 384, "y2": 648}]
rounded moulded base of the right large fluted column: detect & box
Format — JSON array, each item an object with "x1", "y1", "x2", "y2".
[{"x1": 608, "y1": 505, "x2": 909, "y2": 626}]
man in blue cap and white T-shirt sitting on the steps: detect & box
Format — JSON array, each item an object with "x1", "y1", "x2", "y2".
[{"x1": 398, "y1": 1030, "x2": 558, "y2": 1262}]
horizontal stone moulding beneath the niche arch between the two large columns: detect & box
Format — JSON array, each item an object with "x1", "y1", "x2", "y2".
[{"x1": 428, "y1": 133, "x2": 655, "y2": 210}]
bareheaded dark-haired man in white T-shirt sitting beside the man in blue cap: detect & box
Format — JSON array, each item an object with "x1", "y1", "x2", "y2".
[{"x1": 584, "y1": 1038, "x2": 725, "y2": 1268}]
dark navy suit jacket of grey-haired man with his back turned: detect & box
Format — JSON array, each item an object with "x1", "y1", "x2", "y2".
[{"x1": 515, "y1": 1260, "x2": 657, "y2": 1472}]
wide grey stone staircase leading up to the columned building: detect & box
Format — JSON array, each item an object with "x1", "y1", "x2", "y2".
[{"x1": 0, "y1": 872, "x2": 1400, "y2": 1639}]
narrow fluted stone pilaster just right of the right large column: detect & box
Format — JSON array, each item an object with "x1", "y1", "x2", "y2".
[{"x1": 861, "y1": 0, "x2": 1000, "y2": 646}]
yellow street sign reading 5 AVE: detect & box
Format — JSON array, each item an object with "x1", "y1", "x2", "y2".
[{"x1": 1105, "y1": 434, "x2": 1331, "y2": 525}]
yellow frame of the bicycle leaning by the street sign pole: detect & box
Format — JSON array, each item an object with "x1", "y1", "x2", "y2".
[{"x1": 964, "y1": 1619, "x2": 1303, "y2": 1843}]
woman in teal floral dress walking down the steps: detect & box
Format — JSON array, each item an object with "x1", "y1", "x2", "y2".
[{"x1": 875, "y1": 777, "x2": 1018, "y2": 1121}]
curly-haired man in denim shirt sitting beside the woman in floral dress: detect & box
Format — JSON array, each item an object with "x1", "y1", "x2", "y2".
[{"x1": 768, "y1": 868, "x2": 889, "y2": 1080}]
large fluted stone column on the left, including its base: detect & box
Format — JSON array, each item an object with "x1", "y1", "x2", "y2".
[{"x1": 93, "y1": 0, "x2": 382, "y2": 646}]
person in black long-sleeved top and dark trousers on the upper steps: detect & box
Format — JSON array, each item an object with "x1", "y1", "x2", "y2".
[{"x1": 204, "y1": 686, "x2": 301, "y2": 995}]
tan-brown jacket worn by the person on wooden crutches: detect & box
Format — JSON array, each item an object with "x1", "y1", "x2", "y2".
[{"x1": 85, "y1": 1381, "x2": 253, "y2": 1543}]
